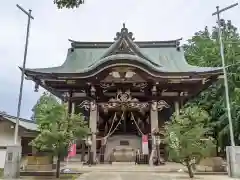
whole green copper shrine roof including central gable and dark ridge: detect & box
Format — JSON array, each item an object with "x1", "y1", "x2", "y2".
[{"x1": 23, "y1": 24, "x2": 221, "y2": 73}]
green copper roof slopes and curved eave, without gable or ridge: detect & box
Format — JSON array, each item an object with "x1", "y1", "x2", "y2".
[{"x1": 24, "y1": 48, "x2": 220, "y2": 73}]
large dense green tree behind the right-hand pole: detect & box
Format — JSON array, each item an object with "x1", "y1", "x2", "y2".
[{"x1": 184, "y1": 20, "x2": 240, "y2": 152}]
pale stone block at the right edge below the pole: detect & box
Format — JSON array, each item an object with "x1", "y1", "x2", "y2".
[{"x1": 226, "y1": 146, "x2": 240, "y2": 178}]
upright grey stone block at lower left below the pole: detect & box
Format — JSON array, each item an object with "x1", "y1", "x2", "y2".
[{"x1": 4, "y1": 145, "x2": 22, "y2": 179}]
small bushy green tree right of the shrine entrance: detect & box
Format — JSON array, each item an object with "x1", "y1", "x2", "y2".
[{"x1": 165, "y1": 106, "x2": 214, "y2": 178}]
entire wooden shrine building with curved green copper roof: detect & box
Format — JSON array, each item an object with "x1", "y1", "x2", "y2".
[{"x1": 21, "y1": 24, "x2": 222, "y2": 162}]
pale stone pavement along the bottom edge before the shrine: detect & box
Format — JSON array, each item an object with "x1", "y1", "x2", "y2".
[{"x1": 77, "y1": 172, "x2": 230, "y2": 180}]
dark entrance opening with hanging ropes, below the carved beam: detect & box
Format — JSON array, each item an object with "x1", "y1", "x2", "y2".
[{"x1": 101, "y1": 109, "x2": 147, "y2": 162}]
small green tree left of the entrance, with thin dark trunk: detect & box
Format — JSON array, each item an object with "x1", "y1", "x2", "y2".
[{"x1": 31, "y1": 93, "x2": 88, "y2": 178}]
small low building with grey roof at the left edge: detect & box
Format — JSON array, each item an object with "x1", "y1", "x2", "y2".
[{"x1": 0, "y1": 112, "x2": 38, "y2": 156}]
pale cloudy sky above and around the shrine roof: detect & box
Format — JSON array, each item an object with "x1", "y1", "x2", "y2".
[{"x1": 0, "y1": 0, "x2": 240, "y2": 118}]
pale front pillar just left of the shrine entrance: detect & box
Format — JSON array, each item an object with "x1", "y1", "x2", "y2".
[{"x1": 89, "y1": 101, "x2": 98, "y2": 162}]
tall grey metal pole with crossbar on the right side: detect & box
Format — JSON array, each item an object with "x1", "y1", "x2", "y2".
[{"x1": 212, "y1": 3, "x2": 238, "y2": 146}]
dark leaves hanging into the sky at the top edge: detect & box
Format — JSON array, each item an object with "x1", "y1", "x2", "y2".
[{"x1": 53, "y1": 0, "x2": 84, "y2": 9}]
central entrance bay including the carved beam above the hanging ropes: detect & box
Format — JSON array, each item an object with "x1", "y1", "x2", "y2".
[{"x1": 96, "y1": 90, "x2": 150, "y2": 162}]
